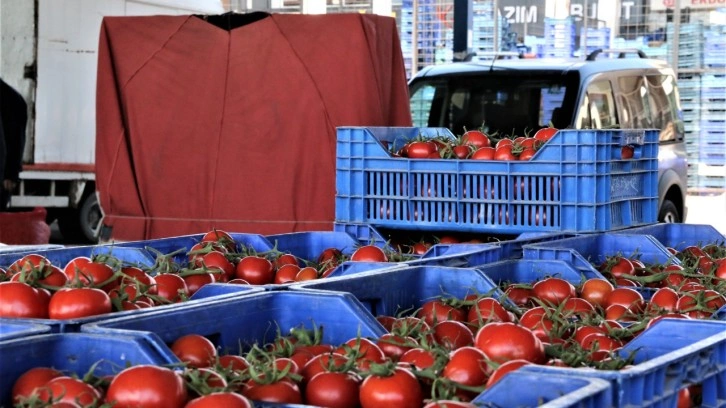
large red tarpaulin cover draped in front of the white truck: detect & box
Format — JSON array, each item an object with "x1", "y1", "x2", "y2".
[{"x1": 96, "y1": 14, "x2": 411, "y2": 240}]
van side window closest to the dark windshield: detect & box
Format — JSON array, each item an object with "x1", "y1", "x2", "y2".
[{"x1": 575, "y1": 81, "x2": 619, "y2": 129}]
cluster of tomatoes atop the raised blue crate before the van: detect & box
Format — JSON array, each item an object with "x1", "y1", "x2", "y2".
[{"x1": 394, "y1": 127, "x2": 557, "y2": 160}]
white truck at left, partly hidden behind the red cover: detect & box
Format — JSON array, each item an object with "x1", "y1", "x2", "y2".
[{"x1": 0, "y1": 0, "x2": 225, "y2": 243}]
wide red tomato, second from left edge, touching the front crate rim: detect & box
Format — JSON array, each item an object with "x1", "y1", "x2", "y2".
[{"x1": 48, "y1": 287, "x2": 113, "y2": 319}]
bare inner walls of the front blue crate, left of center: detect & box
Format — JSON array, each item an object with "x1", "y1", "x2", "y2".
[{"x1": 83, "y1": 291, "x2": 386, "y2": 361}]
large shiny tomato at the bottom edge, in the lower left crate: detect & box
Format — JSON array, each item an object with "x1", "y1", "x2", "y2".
[{"x1": 106, "y1": 365, "x2": 188, "y2": 408}]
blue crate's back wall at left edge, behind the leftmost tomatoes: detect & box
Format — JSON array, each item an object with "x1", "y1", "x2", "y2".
[{"x1": 0, "y1": 245, "x2": 154, "y2": 269}]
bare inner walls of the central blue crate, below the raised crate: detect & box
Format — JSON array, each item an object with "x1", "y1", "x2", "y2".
[{"x1": 291, "y1": 266, "x2": 502, "y2": 316}]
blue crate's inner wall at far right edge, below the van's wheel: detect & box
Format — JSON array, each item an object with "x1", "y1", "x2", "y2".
[{"x1": 619, "y1": 223, "x2": 726, "y2": 251}]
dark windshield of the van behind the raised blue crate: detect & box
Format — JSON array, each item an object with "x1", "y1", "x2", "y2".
[{"x1": 410, "y1": 71, "x2": 579, "y2": 136}]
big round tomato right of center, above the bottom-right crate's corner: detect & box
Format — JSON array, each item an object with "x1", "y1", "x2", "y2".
[{"x1": 474, "y1": 323, "x2": 546, "y2": 364}]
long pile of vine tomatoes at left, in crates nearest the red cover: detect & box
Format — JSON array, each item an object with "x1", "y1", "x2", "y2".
[{"x1": 0, "y1": 230, "x2": 410, "y2": 319}]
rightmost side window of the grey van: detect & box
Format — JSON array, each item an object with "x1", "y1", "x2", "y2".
[{"x1": 646, "y1": 75, "x2": 679, "y2": 142}]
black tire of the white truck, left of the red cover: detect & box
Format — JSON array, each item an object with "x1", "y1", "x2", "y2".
[{"x1": 58, "y1": 193, "x2": 101, "y2": 244}]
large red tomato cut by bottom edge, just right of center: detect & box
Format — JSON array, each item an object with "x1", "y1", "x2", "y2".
[{"x1": 359, "y1": 367, "x2": 423, "y2": 408}]
